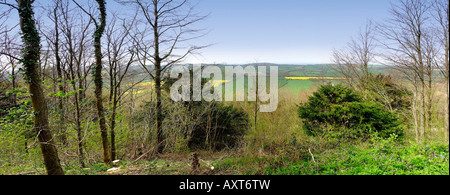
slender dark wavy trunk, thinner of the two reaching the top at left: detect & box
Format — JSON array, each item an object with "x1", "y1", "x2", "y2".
[{"x1": 94, "y1": 0, "x2": 112, "y2": 165}]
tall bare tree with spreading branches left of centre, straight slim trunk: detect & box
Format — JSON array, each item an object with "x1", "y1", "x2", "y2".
[{"x1": 128, "y1": 0, "x2": 206, "y2": 153}]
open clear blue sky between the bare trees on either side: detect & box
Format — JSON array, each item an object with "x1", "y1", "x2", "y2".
[{"x1": 181, "y1": 0, "x2": 390, "y2": 64}]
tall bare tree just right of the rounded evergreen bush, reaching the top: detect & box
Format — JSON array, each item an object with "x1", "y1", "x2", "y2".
[{"x1": 378, "y1": 0, "x2": 435, "y2": 142}]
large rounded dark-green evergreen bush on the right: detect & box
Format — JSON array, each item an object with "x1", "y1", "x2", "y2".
[{"x1": 298, "y1": 84, "x2": 403, "y2": 140}]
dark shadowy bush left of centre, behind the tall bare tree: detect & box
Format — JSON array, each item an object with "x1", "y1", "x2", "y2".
[{"x1": 137, "y1": 96, "x2": 250, "y2": 150}]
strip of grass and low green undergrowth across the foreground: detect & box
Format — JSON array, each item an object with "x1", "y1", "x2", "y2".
[{"x1": 0, "y1": 139, "x2": 449, "y2": 175}]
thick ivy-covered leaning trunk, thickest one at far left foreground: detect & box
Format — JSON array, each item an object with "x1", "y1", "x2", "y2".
[{"x1": 17, "y1": 0, "x2": 64, "y2": 175}]
